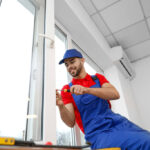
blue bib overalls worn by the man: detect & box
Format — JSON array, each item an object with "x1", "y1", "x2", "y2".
[{"x1": 69, "y1": 76, "x2": 150, "y2": 150}]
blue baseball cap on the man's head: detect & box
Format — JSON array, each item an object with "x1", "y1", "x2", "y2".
[{"x1": 59, "y1": 49, "x2": 83, "y2": 64}]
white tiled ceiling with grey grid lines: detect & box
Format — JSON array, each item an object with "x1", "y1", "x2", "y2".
[{"x1": 79, "y1": 0, "x2": 150, "y2": 62}]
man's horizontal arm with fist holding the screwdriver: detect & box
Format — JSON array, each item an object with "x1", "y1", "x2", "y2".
[{"x1": 70, "y1": 83, "x2": 120, "y2": 100}]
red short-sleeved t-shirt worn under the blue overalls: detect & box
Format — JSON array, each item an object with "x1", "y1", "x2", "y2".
[{"x1": 61, "y1": 73, "x2": 111, "y2": 132}]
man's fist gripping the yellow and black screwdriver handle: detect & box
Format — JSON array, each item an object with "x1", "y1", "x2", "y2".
[{"x1": 70, "y1": 85, "x2": 88, "y2": 95}]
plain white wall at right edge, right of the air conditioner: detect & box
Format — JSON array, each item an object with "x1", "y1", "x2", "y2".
[{"x1": 131, "y1": 57, "x2": 150, "y2": 130}]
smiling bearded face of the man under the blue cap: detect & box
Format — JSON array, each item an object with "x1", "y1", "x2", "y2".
[{"x1": 64, "y1": 58, "x2": 84, "y2": 77}]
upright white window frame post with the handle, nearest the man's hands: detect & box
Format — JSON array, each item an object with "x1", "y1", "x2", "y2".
[{"x1": 43, "y1": 0, "x2": 56, "y2": 144}]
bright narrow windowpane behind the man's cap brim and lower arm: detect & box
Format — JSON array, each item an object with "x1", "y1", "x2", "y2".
[{"x1": 55, "y1": 27, "x2": 73, "y2": 145}]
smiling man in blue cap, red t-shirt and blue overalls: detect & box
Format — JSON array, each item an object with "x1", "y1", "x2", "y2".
[{"x1": 56, "y1": 49, "x2": 150, "y2": 150}]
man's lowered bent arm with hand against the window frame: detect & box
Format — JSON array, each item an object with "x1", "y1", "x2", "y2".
[{"x1": 56, "y1": 91, "x2": 75, "y2": 127}]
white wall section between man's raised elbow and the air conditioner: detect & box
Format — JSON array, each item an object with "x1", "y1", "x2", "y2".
[{"x1": 105, "y1": 65, "x2": 141, "y2": 125}]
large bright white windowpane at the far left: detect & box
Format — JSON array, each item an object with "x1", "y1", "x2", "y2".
[{"x1": 0, "y1": 0, "x2": 34, "y2": 139}]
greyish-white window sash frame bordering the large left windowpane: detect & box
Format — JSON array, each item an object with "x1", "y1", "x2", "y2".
[{"x1": 25, "y1": 0, "x2": 45, "y2": 141}]
